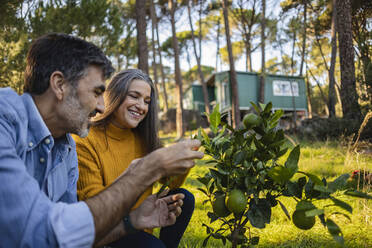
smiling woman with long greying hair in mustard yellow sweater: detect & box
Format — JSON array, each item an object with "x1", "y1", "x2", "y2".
[{"x1": 74, "y1": 69, "x2": 195, "y2": 248}]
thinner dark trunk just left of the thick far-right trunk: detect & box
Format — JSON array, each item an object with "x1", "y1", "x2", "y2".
[{"x1": 328, "y1": 0, "x2": 337, "y2": 117}]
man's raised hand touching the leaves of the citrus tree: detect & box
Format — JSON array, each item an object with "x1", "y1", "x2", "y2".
[{"x1": 143, "y1": 140, "x2": 204, "y2": 178}]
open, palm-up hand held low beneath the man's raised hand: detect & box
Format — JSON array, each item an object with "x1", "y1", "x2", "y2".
[{"x1": 129, "y1": 190, "x2": 185, "y2": 230}]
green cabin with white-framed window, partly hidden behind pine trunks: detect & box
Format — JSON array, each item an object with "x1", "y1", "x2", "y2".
[{"x1": 188, "y1": 71, "x2": 307, "y2": 118}]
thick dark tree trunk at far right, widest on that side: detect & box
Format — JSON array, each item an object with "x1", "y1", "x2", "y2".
[{"x1": 337, "y1": 0, "x2": 361, "y2": 120}]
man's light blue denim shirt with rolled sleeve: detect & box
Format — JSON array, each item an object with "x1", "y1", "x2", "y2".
[{"x1": 0, "y1": 88, "x2": 95, "y2": 248}]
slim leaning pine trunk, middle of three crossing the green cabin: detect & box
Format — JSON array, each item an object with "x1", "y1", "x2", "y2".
[{"x1": 222, "y1": 0, "x2": 240, "y2": 128}]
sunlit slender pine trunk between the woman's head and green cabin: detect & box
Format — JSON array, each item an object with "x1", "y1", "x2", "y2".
[{"x1": 168, "y1": 0, "x2": 185, "y2": 138}]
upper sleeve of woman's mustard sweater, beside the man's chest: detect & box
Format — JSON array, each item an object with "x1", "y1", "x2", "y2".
[{"x1": 73, "y1": 136, "x2": 105, "y2": 200}]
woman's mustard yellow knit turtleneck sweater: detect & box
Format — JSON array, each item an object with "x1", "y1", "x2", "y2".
[{"x1": 73, "y1": 124, "x2": 187, "y2": 209}]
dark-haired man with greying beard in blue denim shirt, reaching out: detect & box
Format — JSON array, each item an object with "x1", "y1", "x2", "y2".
[{"x1": 0, "y1": 34, "x2": 203, "y2": 247}]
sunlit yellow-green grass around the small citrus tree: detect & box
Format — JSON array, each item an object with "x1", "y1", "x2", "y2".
[{"x1": 155, "y1": 136, "x2": 372, "y2": 248}]
